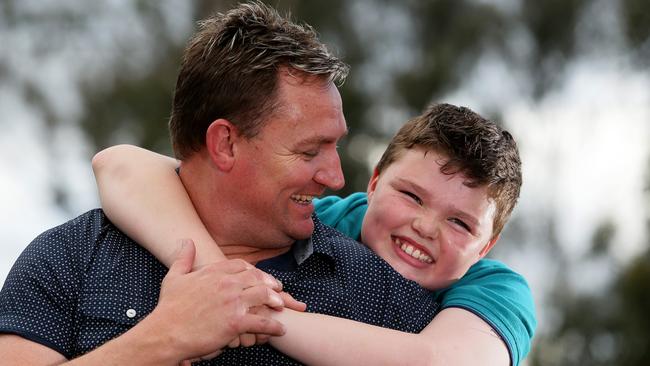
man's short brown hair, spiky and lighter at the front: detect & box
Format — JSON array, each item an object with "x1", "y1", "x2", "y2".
[{"x1": 169, "y1": 2, "x2": 348, "y2": 159}]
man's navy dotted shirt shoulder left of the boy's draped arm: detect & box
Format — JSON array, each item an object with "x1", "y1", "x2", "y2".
[{"x1": 0, "y1": 209, "x2": 166, "y2": 358}]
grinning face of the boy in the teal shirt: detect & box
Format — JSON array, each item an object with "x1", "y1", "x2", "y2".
[{"x1": 361, "y1": 148, "x2": 497, "y2": 290}]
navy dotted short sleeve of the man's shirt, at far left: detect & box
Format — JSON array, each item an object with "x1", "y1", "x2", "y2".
[{"x1": 0, "y1": 210, "x2": 102, "y2": 358}]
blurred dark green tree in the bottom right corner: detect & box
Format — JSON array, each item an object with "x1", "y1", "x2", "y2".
[{"x1": 529, "y1": 156, "x2": 650, "y2": 366}]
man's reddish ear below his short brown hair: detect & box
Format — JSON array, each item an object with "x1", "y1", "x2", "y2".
[{"x1": 205, "y1": 119, "x2": 239, "y2": 171}]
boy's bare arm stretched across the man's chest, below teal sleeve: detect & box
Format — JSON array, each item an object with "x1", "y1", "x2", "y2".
[{"x1": 270, "y1": 308, "x2": 510, "y2": 366}]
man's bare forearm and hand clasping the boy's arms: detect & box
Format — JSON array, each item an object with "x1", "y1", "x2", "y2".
[{"x1": 0, "y1": 242, "x2": 284, "y2": 365}]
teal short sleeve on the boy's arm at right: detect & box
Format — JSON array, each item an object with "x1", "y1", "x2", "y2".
[{"x1": 439, "y1": 259, "x2": 537, "y2": 366}]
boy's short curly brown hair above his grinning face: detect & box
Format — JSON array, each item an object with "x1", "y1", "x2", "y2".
[{"x1": 377, "y1": 104, "x2": 522, "y2": 236}]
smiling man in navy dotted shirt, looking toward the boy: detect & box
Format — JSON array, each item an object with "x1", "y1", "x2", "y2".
[{"x1": 0, "y1": 3, "x2": 532, "y2": 364}]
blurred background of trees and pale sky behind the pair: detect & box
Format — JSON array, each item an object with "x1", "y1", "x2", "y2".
[{"x1": 0, "y1": 0, "x2": 650, "y2": 365}]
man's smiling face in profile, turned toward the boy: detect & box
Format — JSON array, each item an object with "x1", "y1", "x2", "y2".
[{"x1": 232, "y1": 73, "x2": 347, "y2": 246}]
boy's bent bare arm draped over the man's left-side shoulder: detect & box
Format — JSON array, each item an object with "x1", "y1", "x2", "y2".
[{"x1": 93, "y1": 145, "x2": 225, "y2": 268}]
